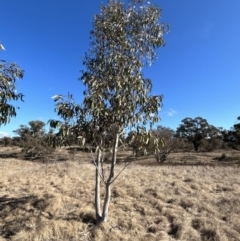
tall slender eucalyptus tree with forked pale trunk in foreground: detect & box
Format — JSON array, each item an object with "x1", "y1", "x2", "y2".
[{"x1": 50, "y1": 0, "x2": 169, "y2": 223}]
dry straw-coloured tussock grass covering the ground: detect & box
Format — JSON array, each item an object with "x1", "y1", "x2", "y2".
[{"x1": 0, "y1": 148, "x2": 240, "y2": 241}]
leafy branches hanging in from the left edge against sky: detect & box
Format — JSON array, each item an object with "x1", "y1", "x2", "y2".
[{"x1": 0, "y1": 57, "x2": 24, "y2": 126}]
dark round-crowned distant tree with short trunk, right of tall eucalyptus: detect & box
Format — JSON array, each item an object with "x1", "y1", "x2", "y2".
[{"x1": 176, "y1": 117, "x2": 218, "y2": 152}]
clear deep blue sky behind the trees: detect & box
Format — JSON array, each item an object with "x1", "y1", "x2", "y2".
[{"x1": 0, "y1": 0, "x2": 240, "y2": 135}]
